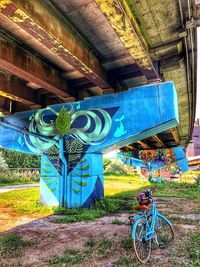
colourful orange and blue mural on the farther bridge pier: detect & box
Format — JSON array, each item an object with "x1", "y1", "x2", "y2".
[{"x1": 117, "y1": 147, "x2": 188, "y2": 182}]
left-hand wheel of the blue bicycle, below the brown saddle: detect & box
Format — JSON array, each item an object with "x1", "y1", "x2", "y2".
[{"x1": 133, "y1": 219, "x2": 151, "y2": 263}]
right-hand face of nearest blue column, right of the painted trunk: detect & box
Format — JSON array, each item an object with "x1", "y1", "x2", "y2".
[{"x1": 65, "y1": 153, "x2": 104, "y2": 208}]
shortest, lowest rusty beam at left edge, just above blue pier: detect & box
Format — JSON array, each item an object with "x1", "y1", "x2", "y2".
[{"x1": 0, "y1": 72, "x2": 41, "y2": 109}]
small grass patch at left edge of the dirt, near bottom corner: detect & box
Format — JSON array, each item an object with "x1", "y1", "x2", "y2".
[{"x1": 0, "y1": 235, "x2": 32, "y2": 258}]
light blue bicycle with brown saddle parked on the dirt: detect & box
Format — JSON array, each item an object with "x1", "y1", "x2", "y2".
[{"x1": 129, "y1": 186, "x2": 174, "y2": 263}]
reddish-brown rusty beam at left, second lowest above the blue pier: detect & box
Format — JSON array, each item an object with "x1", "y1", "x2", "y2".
[{"x1": 0, "y1": 36, "x2": 74, "y2": 101}]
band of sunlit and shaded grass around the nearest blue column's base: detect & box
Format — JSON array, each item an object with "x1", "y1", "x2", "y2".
[{"x1": 0, "y1": 175, "x2": 200, "y2": 223}]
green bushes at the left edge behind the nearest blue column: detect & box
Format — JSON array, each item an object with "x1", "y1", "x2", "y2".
[{"x1": 0, "y1": 149, "x2": 40, "y2": 168}]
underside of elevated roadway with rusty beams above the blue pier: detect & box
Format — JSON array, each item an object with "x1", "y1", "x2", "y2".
[{"x1": 0, "y1": 0, "x2": 200, "y2": 149}]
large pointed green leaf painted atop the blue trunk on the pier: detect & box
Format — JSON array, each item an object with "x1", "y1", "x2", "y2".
[{"x1": 55, "y1": 107, "x2": 70, "y2": 136}]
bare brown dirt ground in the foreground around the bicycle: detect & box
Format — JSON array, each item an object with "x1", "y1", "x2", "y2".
[{"x1": 0, "y1": 198, "x2": 200, "y2": 267}]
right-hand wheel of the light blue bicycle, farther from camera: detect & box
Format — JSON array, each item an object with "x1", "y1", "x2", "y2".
[{"x1": 155, "y1": 215, "x2": 174, "y2": 248}]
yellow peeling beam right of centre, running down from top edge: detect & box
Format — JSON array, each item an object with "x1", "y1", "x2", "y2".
[{"x1": 95, "y1": 0, "x2": 159, "y2": 80}]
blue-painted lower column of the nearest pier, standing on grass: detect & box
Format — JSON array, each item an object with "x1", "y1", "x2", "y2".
[{"x1": 40, "y1": 153, "x2": 104, "y2": 208}]
